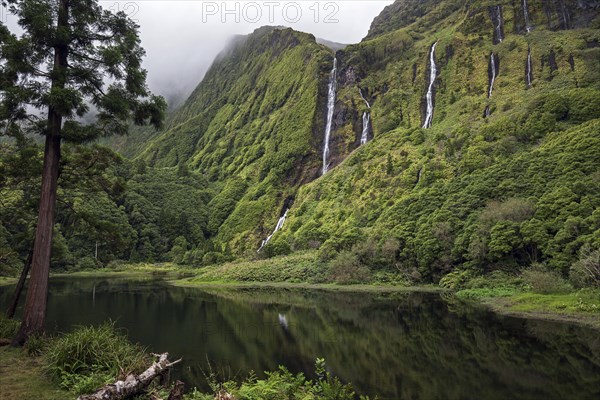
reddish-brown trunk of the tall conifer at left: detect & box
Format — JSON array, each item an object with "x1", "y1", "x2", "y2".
[{"x1": 12, "y1": 0, "x2": 69, "y2": 346}]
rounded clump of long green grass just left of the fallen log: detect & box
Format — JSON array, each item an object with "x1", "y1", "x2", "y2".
[{"x1": 44, "y1": 323, "x2": 150, "y2": 394}]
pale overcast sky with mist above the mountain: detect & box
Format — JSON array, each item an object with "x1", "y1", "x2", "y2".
[{"x1": 5, "y1": 0, "x2": 393, "y2": 106}]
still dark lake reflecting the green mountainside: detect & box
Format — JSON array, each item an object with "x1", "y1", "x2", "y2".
[{"x1": 0, "y1": 278, "x2": 600, "y2": 400}]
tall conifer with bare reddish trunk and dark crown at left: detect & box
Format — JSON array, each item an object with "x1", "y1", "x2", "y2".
[{"x1": 0, "y1": 0, "x2": 166, "y2": 345}]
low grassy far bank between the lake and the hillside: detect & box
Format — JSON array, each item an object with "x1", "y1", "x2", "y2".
[{"x1": 0, "y1": 251, "x2": 600, "y2": 328}]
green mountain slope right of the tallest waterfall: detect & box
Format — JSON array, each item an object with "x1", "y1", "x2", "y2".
[{"x1": 271, "y1": 1, "x2": 600, "y2": 280}]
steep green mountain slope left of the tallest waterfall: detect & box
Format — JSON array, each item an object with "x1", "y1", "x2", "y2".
[{"x1": 131, "y1": 27, "x2": 332, "y2": 253}]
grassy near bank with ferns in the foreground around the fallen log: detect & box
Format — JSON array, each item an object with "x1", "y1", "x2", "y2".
[{"x1": 0, "y1": 318, "x2": 368, "y2": 400}]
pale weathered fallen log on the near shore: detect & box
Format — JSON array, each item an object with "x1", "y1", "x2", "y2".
[{"x1": 77, "y1": 353, "x2": 181, "y2": 400}]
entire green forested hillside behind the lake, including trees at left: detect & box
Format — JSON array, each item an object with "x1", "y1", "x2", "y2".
[{"x1": 0, "y1": 0, "x2": 600, "y2": 282}]
